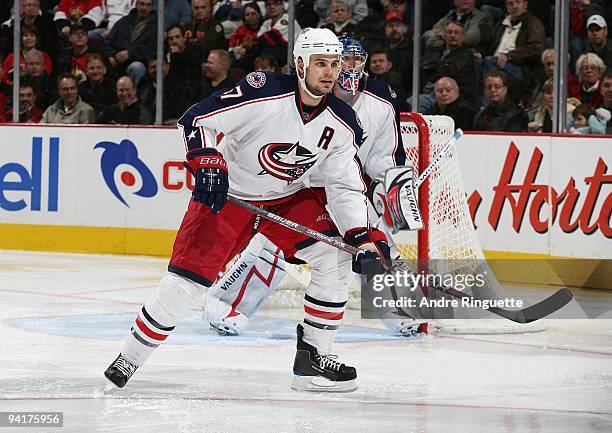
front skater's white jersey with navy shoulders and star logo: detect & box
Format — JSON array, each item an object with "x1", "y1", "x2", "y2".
[{"x1": 178, "y1": 72, "x2": 368, "y2": 233}]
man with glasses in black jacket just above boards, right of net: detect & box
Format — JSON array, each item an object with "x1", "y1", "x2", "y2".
[{"x1": 473, "y1": 71, "x2": 528, "y2": 132}]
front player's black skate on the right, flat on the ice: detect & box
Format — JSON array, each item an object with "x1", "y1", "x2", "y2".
[{"x1": 291, "y1": 325, "x2": 357, "y2": 392}]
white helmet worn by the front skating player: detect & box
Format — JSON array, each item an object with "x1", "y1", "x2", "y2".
[{"x1": 293, "y1": 27, "x2": 342, "y2": 97}]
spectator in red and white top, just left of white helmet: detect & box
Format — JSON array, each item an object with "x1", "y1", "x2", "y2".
[{"x1": 253, "y1": 0, "x2": 302, "y2": 66}]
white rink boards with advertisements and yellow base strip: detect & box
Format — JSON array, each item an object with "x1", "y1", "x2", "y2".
[{"x1": 0, "y1": 125, "x2": 612, "y2": 287}]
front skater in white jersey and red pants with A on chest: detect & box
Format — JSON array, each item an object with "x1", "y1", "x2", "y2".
[{"x1": 105, "y1": 29, "x2": 391, "y2": 391}]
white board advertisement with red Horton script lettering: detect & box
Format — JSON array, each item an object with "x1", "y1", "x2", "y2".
[{"x1": 457, "y1": 134, "x2": 612, "y2": 258}]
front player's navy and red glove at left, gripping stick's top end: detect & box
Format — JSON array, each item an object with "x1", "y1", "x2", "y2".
[{"x1": 185, "y1": 148, "x2": 229, "y2": 213}]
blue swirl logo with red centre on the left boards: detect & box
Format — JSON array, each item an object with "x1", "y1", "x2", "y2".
[{"x1": 94, "y1": 140, "x2": 157, "y2": 207}]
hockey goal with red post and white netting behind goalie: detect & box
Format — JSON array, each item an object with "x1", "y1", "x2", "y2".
[{"x1": 268, "y1": 113, "x2": 532, "y2": 332}]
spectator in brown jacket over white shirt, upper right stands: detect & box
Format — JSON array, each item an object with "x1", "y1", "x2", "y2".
[{"x1": 481, "y1": 0, "x2": 546, "y2": 99}]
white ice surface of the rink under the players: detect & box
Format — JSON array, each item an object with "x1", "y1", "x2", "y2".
[{"x1": 0, "y1": 251, "x2": 612, "y2": 433}]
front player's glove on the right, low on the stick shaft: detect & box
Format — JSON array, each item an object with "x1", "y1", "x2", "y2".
[{"x1": 344, "y1": 227, "x2": 393, "y2": 275}]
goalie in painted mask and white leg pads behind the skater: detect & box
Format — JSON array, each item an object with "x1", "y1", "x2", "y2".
[{"x1": 202, "y1": 36, "x2": 425, "y2": 336}]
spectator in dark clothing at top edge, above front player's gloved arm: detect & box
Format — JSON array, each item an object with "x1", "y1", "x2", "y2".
[{"x1": 185, "y1": 0, "x2": 227, "y2": 59}]
